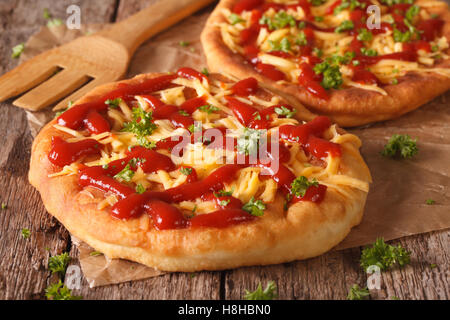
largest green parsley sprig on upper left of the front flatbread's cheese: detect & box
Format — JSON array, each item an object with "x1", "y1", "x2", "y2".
[{"x1": 122, "y1": 107, "x2": 157, "y2": 148}]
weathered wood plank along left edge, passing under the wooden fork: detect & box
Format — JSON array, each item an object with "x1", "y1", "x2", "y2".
[{"x1": 0, "y1": 0, "x2": 115, "y2": 299}]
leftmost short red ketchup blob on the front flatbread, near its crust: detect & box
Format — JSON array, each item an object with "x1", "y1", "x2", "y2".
[{"x1": 48, "y1": 137, "x2": 101, "y2": 167}]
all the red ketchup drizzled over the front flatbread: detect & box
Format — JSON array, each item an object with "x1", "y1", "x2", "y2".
[{"x1": 48, "y1": 67, "x2": 341, "y2": 230}]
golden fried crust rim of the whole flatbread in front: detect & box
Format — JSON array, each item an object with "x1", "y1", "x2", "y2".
[{"x1": 29, "y1": 74, "x2": 370, "y2": 271}]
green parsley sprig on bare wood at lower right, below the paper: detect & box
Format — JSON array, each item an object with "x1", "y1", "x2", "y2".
[{"x1": 360, "y1": 238, "x2": 411, "y2": 270}]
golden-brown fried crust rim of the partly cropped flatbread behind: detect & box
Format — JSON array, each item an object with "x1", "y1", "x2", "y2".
[{"x1": 201, "y1": 0, "x2": 450, "y2": 127}]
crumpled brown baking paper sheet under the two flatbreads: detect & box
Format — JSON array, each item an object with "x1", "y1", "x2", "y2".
[{"x1": 22, "y1": 10, "x2": 450, "y2": 287}]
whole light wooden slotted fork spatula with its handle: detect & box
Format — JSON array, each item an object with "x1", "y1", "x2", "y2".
[{"x1": 0, "y1": 0, "x2": 213, "y2": 111}]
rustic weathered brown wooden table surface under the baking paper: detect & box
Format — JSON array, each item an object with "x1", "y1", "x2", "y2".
[{"x1": 0, "y1": 0, "x2": 450, "y2": 299}]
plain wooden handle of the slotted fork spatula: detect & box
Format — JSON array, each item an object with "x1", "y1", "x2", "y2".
[{"x1": 96, "y1": 0, "x2": 214, "y2": 54}]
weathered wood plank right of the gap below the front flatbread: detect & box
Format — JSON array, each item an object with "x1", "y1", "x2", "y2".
[{"x1": 225, "y1": 231, "x2": 450, "y2": 299}]
